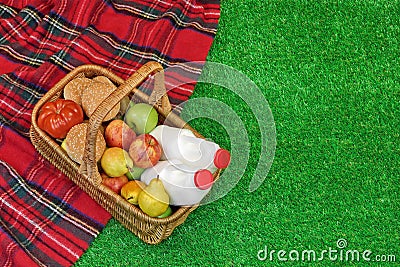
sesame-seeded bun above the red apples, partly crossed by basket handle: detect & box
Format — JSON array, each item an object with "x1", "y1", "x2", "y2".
[{"x1": 82, "y1": 80, "x2": 120, "y2": 121}]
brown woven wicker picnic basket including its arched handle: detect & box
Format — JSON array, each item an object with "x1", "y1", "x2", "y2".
[{"x1": 30, "y1": 62, "x2": 220, "y2": 244}]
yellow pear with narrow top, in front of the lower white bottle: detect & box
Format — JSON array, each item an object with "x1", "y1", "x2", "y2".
[{"x1": 138, "y1": 177, "x2": 169, "y2": 217}]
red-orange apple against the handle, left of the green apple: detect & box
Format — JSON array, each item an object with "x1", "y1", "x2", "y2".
[{"x1": 104, "y1": 119, "x2": 136, "y2": 150}]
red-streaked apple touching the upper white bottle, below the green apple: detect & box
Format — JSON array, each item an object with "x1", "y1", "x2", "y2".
[{"x1": 129, "y1": 134, "x2": 162, "y2": 169}]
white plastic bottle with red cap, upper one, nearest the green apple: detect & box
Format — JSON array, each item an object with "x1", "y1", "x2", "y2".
[{"x1": 150, "y1": 125, "x2": 231, "y2": 172}]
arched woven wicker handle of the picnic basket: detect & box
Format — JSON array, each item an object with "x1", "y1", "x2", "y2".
[{"x1": 79, "y1": 61, "x2": 171, "y2": 183}]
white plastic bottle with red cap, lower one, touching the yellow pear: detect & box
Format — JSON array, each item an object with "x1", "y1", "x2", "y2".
[{"x1": 140, "y1": 161, "x2": 214, "y2": 206}]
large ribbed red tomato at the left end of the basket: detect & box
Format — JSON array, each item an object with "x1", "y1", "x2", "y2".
[{"x1": 38, "y1": 99, "x2": 83, "y2": 139}]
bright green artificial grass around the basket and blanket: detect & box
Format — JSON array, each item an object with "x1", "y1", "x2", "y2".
[{"x1": 76, "y1": 0, "x2": 400, "y2": 266}]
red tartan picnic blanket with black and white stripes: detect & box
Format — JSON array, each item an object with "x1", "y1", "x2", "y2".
[{"x1": 0, "y1": 0, "x2": 220, "y2": 266}]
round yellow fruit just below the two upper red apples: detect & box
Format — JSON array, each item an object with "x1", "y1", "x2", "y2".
[{"x1": 100, "y1": 147, "x2": 133, "y2": 177}]
